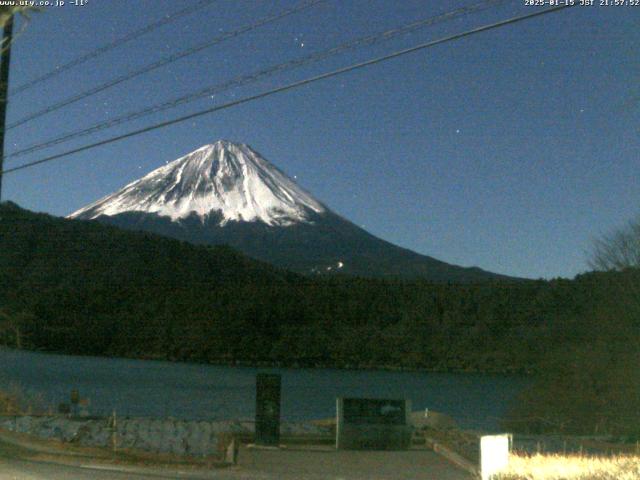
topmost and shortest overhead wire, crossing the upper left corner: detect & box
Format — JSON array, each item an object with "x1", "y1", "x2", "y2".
[{"x1": 9, "y1": 0, "x2": 217, "y2": 95}]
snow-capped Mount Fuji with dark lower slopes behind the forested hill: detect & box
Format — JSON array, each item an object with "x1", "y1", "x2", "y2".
[{"x1": 68, "y1": 140, "x2": 509, "y2": 282}]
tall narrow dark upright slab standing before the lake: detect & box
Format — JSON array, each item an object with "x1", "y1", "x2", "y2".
[{"x1": 255, "y1": 373, "x2": 281, "y2": 447}]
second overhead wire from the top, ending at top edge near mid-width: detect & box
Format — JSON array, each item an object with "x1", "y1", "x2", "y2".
[{"x1": 6, "y1": 0, "x2": 326, "y2": 130}]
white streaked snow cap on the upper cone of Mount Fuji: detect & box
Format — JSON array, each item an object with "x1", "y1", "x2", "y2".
[{"x1": 69, "y1": 140, "x2": 326, "y2": 226}]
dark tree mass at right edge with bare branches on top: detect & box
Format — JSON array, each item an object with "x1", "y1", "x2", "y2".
[{"x1": 505, "y1": 223, "x2": 640, "y2": 438}]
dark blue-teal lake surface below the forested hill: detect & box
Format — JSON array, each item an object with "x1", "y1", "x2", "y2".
[{"x1": 0, "y1": 348, "x2": 529, "y2": 430}]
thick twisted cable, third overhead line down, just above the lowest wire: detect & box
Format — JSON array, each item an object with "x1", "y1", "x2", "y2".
[{"x1": 5, "y1": 0, "x2": 511, "y2": 159}]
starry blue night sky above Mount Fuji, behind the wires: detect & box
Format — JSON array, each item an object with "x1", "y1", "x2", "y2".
[{"x1": 3, "y1": 0, "x2": 640, "y2": 278}]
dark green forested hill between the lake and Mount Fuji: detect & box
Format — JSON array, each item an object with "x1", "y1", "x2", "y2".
[{"x1": 0, "y1": 203, "x2": 624, "y2": 371}]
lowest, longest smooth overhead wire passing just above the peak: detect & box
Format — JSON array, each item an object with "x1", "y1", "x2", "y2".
[{"x1": 0, "y1": 4, "x2": 577, "y2": 174}]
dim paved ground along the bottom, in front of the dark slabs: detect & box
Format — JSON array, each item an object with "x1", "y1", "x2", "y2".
[{"x1": 0, "y1": 444, "x2": 471, "y2": 480}]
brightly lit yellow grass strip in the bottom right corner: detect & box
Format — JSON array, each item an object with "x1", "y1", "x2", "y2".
[{"x1": 496, "y1": 454, "x2": 640, "y2": 480}]
